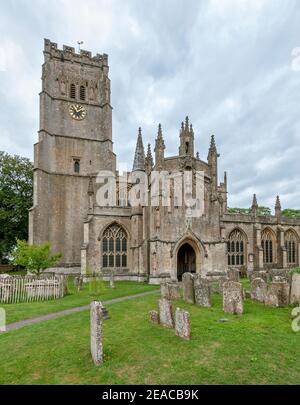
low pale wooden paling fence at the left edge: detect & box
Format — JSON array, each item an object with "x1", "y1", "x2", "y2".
[{"x1": 0, "y1": 276, "x2": 66, "y2": 304}]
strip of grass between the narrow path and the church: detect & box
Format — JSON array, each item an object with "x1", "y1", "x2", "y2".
[{"x1": 1, "y1": 277, "x2": 159, "y2": 323}]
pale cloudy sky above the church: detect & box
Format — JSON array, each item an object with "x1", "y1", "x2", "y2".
[{"x1": 0, "y1": 0, "x2": 300, "y2": 208}]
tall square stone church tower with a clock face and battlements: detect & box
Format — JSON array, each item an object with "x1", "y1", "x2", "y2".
[{"x1": 29, "y1": 39, "x2": 116, "y2": 268}]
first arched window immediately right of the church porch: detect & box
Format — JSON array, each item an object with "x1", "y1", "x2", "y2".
[{"x1": 227, "y1": 229, "x2": 246, "y2": 266}]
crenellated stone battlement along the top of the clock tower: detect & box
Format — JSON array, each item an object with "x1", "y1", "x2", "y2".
[{"x1": 44, "y1": 39, "x2": 108, "y2": 68}]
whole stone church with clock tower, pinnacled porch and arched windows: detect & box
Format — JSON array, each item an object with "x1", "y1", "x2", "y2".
[{"x1": 29, "y1": 40, "x2": 300, "y2": 283}]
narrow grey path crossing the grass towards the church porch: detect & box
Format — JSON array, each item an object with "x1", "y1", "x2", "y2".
[{"x1": 6, "y1": 290, "x2": 159, "y2": 332}]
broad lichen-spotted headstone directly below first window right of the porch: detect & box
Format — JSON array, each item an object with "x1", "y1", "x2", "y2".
[{"x1": 223, "y1": 281, "x2": 244, "y2": 314}]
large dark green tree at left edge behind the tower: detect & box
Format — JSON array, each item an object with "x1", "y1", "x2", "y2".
[{"x1": 0, "y1": 151, "x2": 33, "y2": 262}]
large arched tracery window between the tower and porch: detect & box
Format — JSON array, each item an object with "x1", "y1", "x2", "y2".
[{"x1": 102, "y1": 224, "x2": 127, "y2": 268}]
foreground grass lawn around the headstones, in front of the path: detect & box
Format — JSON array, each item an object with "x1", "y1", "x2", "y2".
[{"x1": 0, "y1": 294, "x2": 300, "y2": 384}]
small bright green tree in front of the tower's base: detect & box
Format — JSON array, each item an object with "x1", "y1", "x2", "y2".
[{"x1": 12, "y1": 240, "x2": 62, "y2": 274}]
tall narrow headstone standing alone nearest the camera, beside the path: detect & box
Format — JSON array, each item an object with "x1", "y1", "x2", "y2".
[{"x1": 90, "y1": 301, "x2": 103, "y2": 365}]
